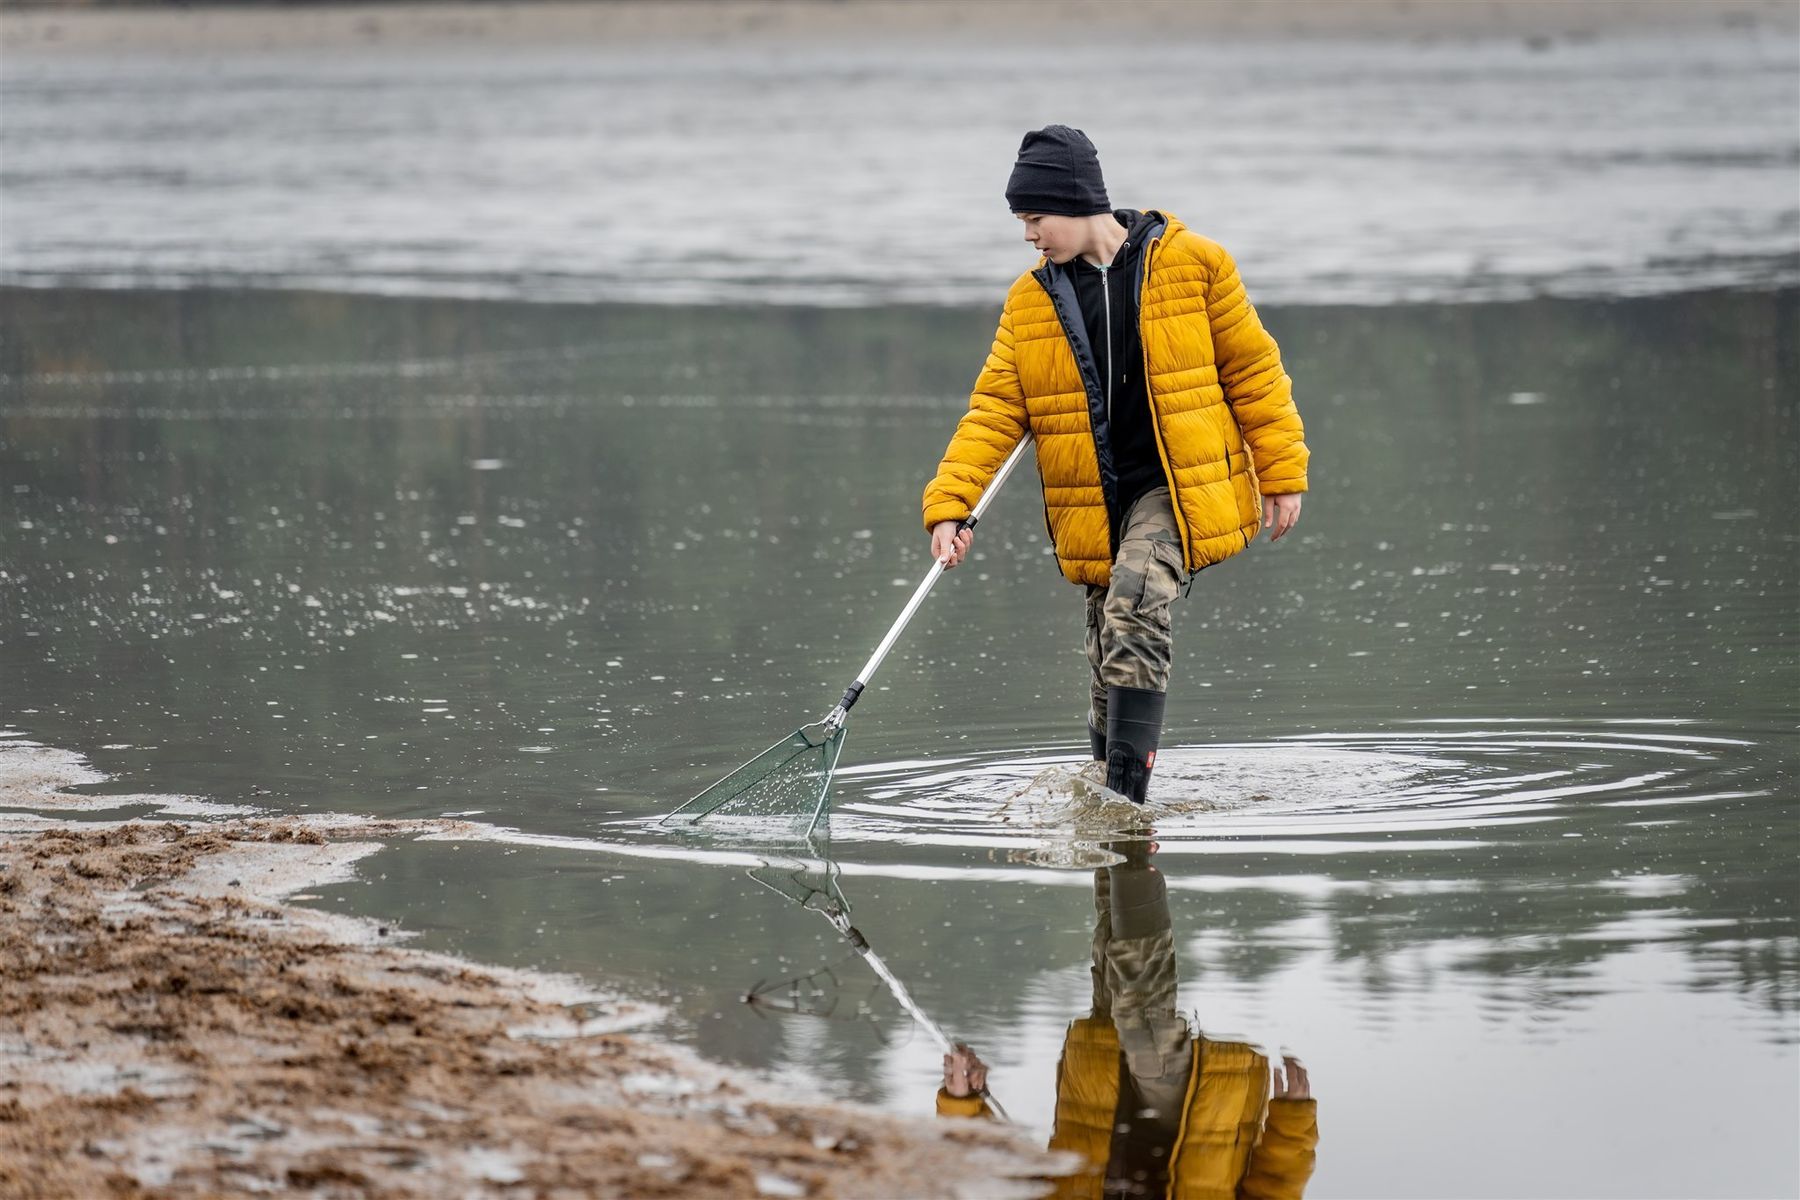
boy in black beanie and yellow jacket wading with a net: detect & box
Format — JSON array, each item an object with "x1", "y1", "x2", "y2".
[{"x1": 925, "y1": 124, "x2": 1307, "y2": 804}]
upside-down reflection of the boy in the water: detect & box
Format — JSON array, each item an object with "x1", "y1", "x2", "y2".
[{"x1": 938, "y1": 842, "x2": 1319, "y2": 1198}]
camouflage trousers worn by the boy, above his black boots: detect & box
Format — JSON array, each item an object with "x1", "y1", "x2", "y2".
[{"x1": 1087, "y1": 488, "x2": 1188, "y2": 732}]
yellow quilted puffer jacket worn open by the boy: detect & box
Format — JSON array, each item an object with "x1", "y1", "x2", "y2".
[{"x1": 925, "y1": 214, "x2": 1307, "y2": 587}]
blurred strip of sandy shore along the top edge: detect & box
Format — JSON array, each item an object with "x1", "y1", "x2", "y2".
[{"x1": 0, "y1": 0, "x2": 1800, "y2": 52}]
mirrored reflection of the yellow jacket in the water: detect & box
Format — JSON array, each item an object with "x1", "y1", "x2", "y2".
[{"x1": 938, "y1": 1016, "x2": 1319, "y2": 1200}]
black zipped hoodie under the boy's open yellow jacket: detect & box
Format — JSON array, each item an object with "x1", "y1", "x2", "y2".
[{"x1": 1066, "y1": 209, "x2": 1168, "y2": 533}]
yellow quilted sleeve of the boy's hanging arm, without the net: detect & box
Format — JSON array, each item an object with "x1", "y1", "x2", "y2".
[{"x1": 1206, "y1": 250, "x2": 1309, "y2": 497}]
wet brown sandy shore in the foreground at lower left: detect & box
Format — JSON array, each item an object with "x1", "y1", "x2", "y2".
[{"x1": 0, "y1": 743, "x2": 1057, "y2": 1198}]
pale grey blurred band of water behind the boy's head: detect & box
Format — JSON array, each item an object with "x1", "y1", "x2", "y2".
[{"x1": 0, "y1": 28, "x2": 1800, "y2": 306}]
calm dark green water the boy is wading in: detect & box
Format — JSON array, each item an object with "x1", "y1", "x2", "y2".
[{"x1": 0, "y1": 290, "x2": 1800, "y2": 1195}]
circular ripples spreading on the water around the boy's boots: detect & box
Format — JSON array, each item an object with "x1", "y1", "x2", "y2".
[{"x1": 810, "y1": 721, "x2": 1764, "y2": 865}]
